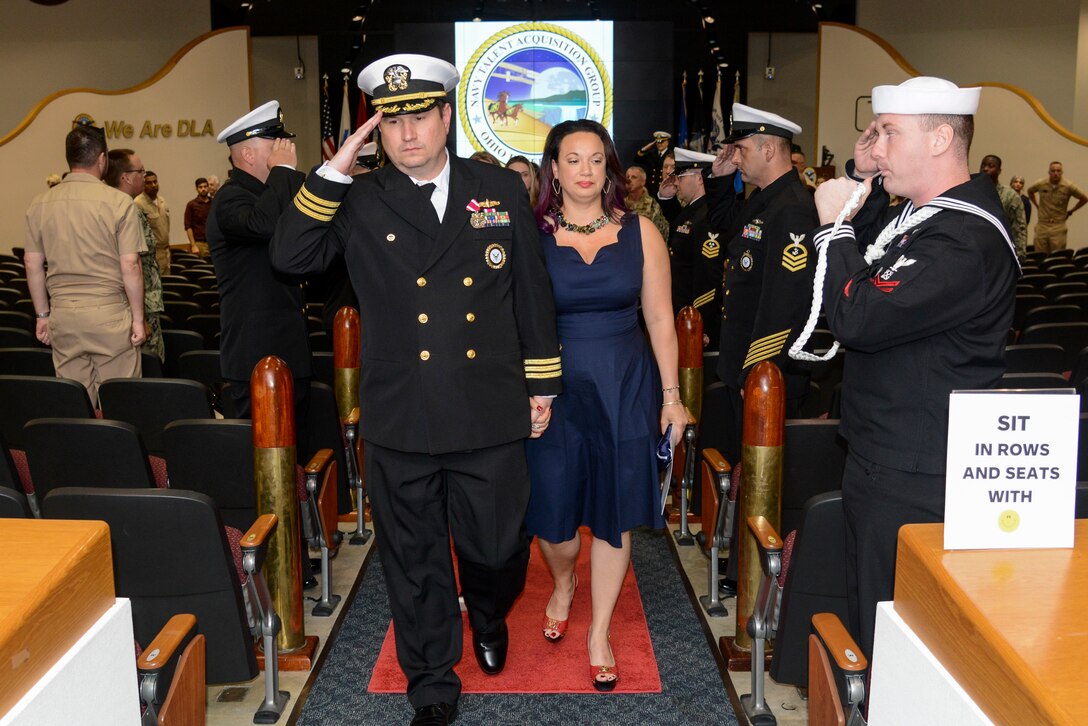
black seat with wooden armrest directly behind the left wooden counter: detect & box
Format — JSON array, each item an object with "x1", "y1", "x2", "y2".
[{"x1": 42, "y1": 488, "x2": 290, "y2": 724}]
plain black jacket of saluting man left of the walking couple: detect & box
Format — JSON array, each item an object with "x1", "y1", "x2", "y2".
[{"x1": 208, "y1": 167, "x2": 310, "y2": 381}]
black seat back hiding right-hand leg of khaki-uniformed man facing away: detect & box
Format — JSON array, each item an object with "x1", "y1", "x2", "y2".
[{"x1": 98, "y1": 378, "x2": 215, "y2": 456}]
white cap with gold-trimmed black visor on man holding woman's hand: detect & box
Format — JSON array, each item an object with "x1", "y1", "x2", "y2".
[{"x1": 359, "y1": 53, "x2": 460, "y2": 115}]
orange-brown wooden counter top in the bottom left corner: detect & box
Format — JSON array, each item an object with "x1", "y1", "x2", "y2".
[{"x1": 0, "y1": 519, "x2": 116, "y2": 717}]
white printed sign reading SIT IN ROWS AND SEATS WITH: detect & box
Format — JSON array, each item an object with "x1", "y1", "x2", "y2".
[{"x1": 944, "y1": 389, "x2": 1080, "y2": 550}]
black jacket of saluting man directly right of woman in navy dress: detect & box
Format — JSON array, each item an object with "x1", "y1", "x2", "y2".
[{"x1": 669, "y1": 196, "x2": 726, "y2": 350}]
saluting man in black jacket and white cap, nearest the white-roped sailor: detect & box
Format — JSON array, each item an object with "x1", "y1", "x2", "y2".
[{"x1": 706, "y1": 103, "x2": 817, "y2": 594}]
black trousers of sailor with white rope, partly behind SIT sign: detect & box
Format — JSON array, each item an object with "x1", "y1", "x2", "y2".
[{"x1": 842, "y1": 447, "x2": 944, "y2": 661}]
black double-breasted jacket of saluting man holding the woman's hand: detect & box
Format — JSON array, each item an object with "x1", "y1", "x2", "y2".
[{"x1": 272, "y1": 156, "x2": 561, "y2": 454}]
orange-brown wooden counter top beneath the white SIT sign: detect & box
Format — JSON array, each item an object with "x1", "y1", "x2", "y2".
[{"x1": 887, "y1": 519, "x2": 1088, "y2": 725}]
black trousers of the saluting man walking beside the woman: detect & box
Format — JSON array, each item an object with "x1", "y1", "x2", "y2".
[{"x1": 363, "y1": 441, "x2": 529, "y2": 709}]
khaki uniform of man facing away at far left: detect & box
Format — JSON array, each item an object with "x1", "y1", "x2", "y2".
[{"x1": 24, "y1": 172, "x2": 147, "y2": 403}]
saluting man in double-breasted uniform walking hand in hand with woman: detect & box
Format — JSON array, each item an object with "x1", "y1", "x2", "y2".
[{"x1": 272, "y1": 54, "x2": 560, "y2": 725}]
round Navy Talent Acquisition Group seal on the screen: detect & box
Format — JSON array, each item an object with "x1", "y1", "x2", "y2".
[{"x1": 457, "y1": 23, "x2": 613, "y2": 161}]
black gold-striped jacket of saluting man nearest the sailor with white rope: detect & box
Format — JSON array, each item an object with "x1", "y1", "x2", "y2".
[{"x1": 706, "y1": 169, "x2": 819, "y2": 398}]
